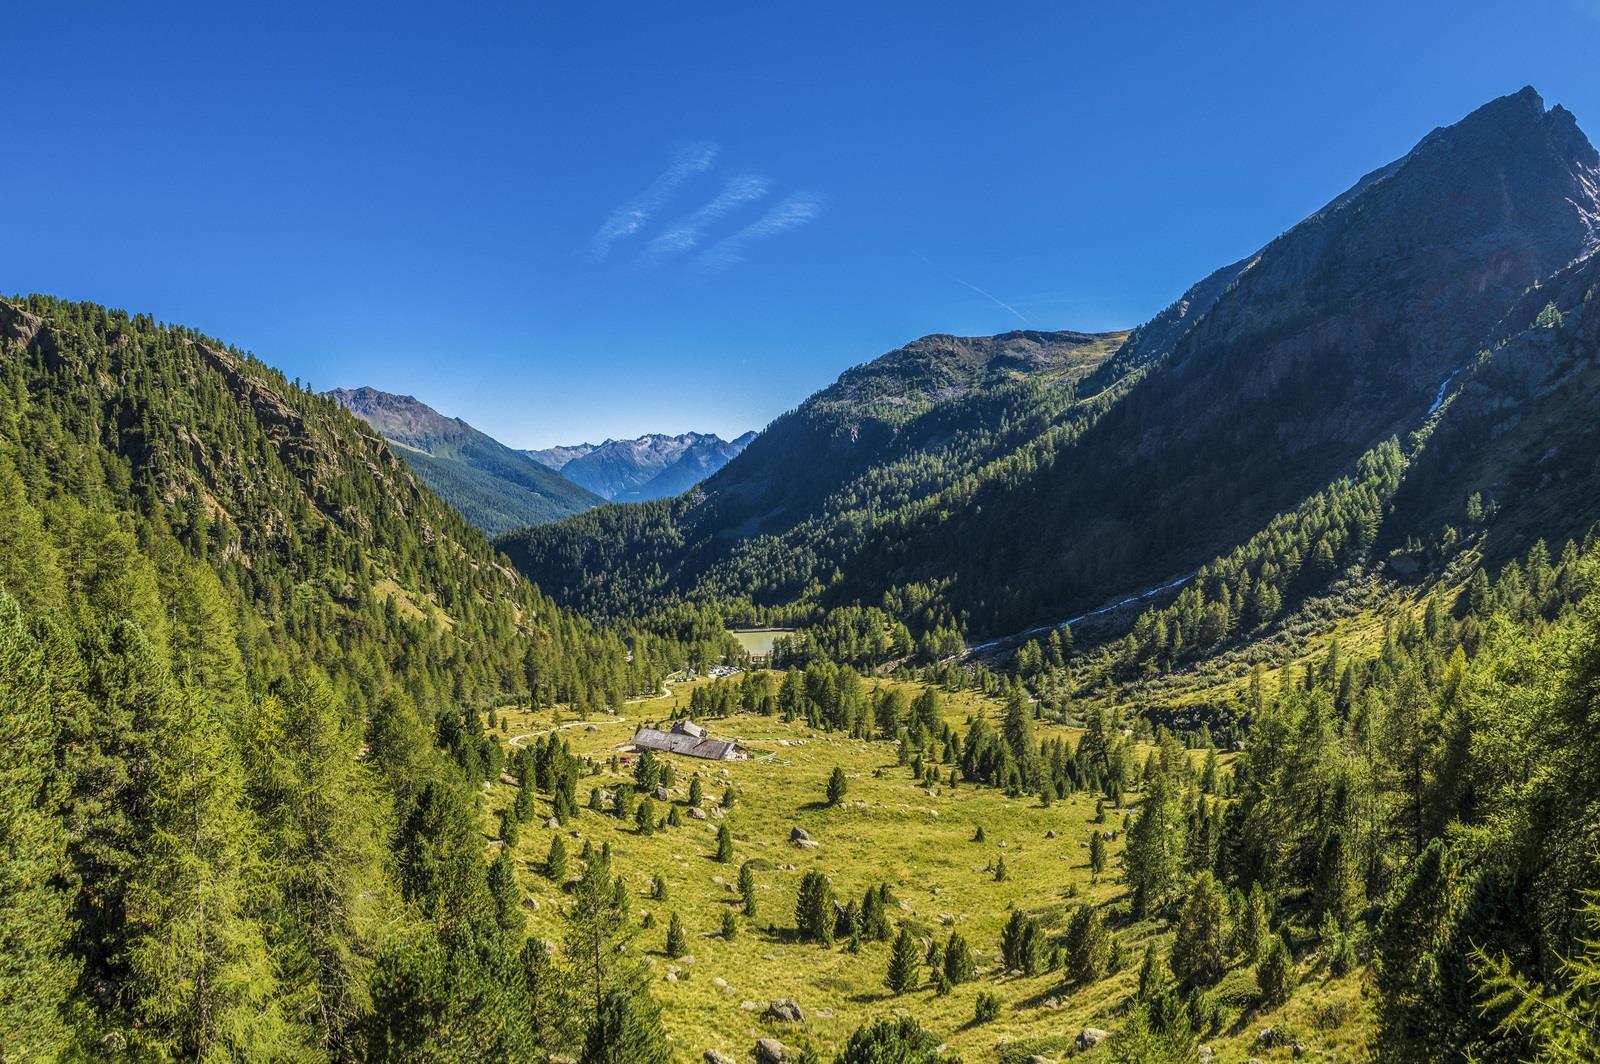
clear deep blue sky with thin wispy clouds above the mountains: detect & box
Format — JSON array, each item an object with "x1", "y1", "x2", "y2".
[{"x1": 9, "y1": 0, "x2": 1600, "y2": 446}]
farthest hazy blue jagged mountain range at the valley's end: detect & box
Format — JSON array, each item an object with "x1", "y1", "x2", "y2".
[{"x1": 523, "y1": 432, "x2": 755, "y2": 502}]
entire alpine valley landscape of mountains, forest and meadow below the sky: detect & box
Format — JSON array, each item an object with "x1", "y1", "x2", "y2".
[{"x1": 0, "y1": 88, "x2": 1600, "y2": 1064}]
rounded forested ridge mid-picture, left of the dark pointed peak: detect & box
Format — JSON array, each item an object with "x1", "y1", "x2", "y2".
[{"x1": 499, "y1": 333, "x2": 1125, "y2": 614}]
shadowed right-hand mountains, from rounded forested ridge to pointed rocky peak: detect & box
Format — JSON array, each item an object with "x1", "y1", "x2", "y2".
[{"x1": 504, "y1": 90, "x2": 1600, "y2": 637}]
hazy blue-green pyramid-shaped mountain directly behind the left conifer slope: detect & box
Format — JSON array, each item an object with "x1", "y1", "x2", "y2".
[{"x1": 328, "y1": 387, "x2": 602, "y2": 536}]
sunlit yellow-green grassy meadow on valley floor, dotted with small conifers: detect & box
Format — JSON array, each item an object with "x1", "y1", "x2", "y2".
[{"x1": 485, "y1": 680, "x2": 1368, "y2": 1062}]
